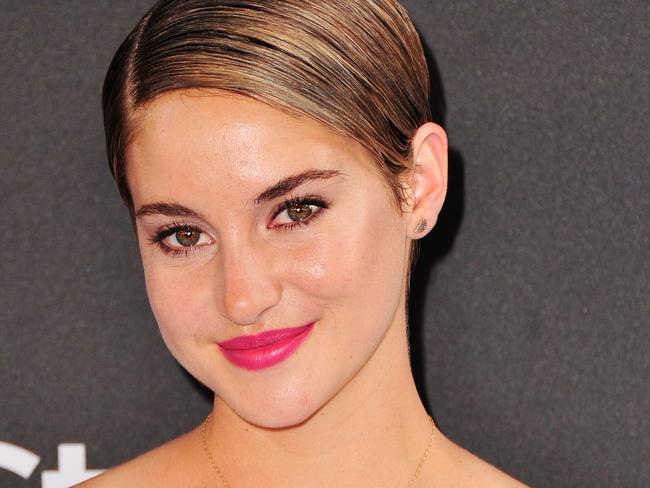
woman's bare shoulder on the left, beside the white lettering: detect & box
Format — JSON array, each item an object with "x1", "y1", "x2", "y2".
[{"x1": 75, "y1": 429, "x2": 205, "y2": 488}]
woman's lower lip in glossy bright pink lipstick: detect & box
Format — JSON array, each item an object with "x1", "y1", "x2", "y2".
[{"x1": 219, "y1": 323, "x2": 314, "y2": 371}]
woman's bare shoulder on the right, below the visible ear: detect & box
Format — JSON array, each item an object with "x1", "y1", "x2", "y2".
[{"x1": 427, "y1": 434, "x2": 526, "y2": 488}]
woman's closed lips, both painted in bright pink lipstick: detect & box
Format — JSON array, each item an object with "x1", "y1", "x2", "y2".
[{"x1": 218, "y1": 322, "x2": 314, "y2": 370}]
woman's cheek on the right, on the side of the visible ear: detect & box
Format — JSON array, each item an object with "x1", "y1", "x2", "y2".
[{"x1": 284, "y1": 197, "x2": 406, "y2": 335}]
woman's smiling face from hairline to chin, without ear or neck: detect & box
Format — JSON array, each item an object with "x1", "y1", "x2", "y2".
[{"x1": 127, "y1": 91, "x2": 409, "y2": 427}]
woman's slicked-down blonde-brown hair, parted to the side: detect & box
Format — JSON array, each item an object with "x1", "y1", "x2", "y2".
[{"x1": 102, "y1": 0, "x2": 431, "y2": 212}]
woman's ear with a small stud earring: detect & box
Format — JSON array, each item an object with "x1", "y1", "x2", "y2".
[{"x1": 405, "y1": 122, "x2": 448, "y2": 239}]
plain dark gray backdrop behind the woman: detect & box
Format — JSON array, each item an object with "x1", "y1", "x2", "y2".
[{"x1": 0, "y1": 0, "x2": 650, "y2": 487}]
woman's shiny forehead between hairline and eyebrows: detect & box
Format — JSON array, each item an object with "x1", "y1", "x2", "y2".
[{"x1": 126, "y1": 90, "x2": 378, "y2": 201}]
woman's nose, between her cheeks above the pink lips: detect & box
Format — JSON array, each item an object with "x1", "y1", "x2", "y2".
[{"x1": 220, "y1": 237, "x2": 282, "y2": 326}]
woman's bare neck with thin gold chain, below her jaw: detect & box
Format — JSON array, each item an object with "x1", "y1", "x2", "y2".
[{"x1": 208, "y1": 294, "x2": 431, "y2": 488}]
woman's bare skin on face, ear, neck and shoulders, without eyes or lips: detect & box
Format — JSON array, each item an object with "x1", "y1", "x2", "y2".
[{"x1": 78, "y1": 91, "x2": 521, "y2": 487}]
